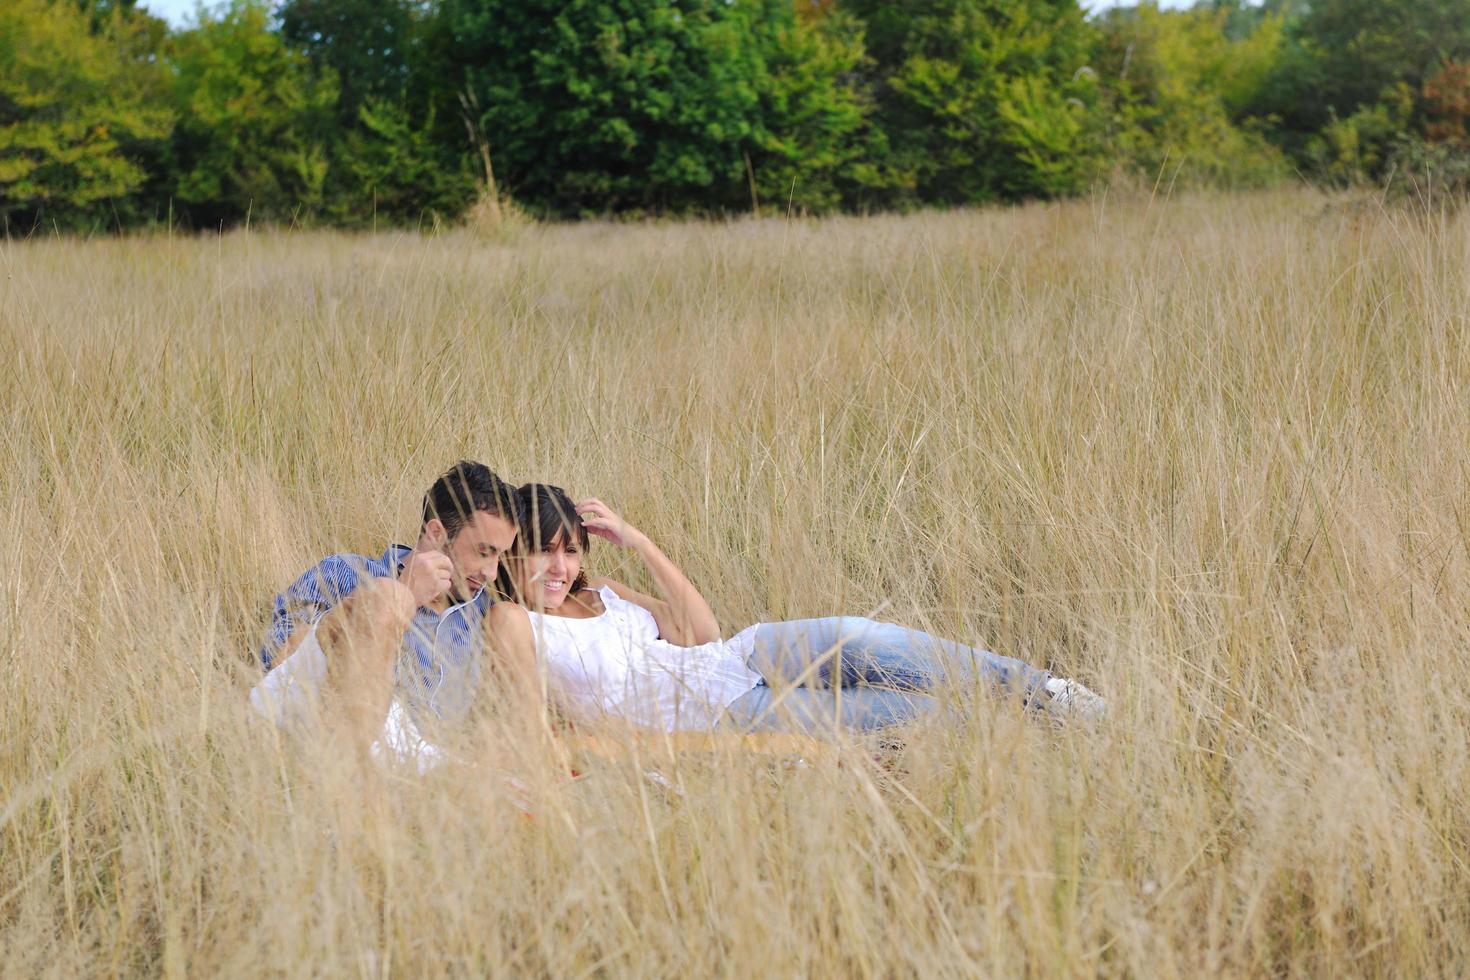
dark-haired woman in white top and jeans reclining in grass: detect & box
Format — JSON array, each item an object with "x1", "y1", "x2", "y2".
[{"x1": 488, "y1": 483, "x2": 1104, "y2": 733}]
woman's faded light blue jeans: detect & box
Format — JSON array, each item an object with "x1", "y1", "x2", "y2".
[{"x1": 720, "y1": 616, "x2": 1051, "y2": 735}]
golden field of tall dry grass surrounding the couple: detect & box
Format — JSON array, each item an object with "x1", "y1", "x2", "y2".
[{"x1": 0, "y1": 191, "x2": 1470, "y2": 977}]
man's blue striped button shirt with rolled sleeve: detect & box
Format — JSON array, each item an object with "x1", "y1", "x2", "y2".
[{"x1": 260, "y1": 545, "x2": 494, "y2": 721}]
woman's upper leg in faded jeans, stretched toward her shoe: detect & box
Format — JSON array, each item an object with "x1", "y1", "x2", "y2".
[{"x1": 750, "y1": 616, "x2": 1051, "y2": 699}]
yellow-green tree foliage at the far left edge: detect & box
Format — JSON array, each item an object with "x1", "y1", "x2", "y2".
[{"x1": 0, "y1": 0, "x2": 171, "y2": 228}]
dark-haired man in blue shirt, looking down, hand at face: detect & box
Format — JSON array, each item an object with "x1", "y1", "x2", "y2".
[{"x1": 250, "y1": 460, "x2": 517, "y2": 755}]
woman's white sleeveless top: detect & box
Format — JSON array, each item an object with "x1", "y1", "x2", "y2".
[{"x1": 531, "y1": 586, "x2": 761, "y2": 732}]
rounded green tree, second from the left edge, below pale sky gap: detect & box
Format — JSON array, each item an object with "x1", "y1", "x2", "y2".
[{"x1": 171, "y1": 0, "x2": 337, "y2": 228}]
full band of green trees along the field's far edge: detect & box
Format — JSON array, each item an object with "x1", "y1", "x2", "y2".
[{"x1": 0, "y1": 0, "x2": 1470, "y2": 235}]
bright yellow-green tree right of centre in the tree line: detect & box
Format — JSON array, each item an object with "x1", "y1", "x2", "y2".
[{"x1": 1098, "y1": 3, "x2": 1286, "y2": 187}]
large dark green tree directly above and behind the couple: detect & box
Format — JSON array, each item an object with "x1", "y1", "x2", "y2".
[{"x1": 445, "y1": 0, "x2": 759, "y2": 215}]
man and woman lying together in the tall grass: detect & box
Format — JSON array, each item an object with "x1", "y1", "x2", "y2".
[{"x1": 251, "y1": 461, "x2": 1104, "y2": 765}]
